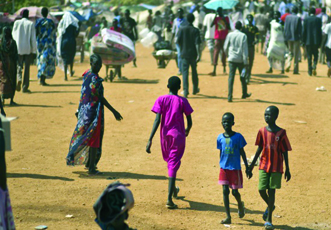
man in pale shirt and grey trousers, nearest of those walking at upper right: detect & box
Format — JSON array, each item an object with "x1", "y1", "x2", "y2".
[{"x1": 224, "y1": 21, "x2": 251, "y2": 102}]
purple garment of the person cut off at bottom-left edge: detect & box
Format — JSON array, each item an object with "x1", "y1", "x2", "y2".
[{"x1": 0, "y1": 188, "x2": 15, "y2": 230}]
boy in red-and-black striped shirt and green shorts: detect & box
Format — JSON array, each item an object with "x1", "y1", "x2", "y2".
[{"x1": 249, "y1": 106, "x2": 292, "y2": 229}]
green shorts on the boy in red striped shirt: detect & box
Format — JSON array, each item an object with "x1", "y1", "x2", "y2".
[{"x1": 259, "y1": 170, "x2": 282, "y2": 190}]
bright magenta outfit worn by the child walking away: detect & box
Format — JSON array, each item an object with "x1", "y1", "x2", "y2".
[{"x1": 152, "y1": 95, "x2": 193, "y2": 177}]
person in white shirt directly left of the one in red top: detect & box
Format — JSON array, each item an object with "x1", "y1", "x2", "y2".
[{"x1": 203, "y1": 13, "x2": 215, "y2": 64}]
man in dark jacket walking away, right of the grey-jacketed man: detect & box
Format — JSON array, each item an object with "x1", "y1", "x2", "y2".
[{"x1": 302, "y1": 7, "x2": 322, "y2": 76}]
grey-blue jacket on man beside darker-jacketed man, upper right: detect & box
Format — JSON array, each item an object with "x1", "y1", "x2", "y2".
[{"x1": 284, "y1": 14, "x2": 301, "y2": 41}]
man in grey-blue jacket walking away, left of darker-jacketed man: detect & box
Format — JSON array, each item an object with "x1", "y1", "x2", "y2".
[{"x1": 284, "y1": 6, "x2": 302, "y2": 74}]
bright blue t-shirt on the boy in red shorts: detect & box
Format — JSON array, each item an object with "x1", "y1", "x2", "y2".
[{"x1": 217, "y1": 133, "x2": 247, "y2": 170}]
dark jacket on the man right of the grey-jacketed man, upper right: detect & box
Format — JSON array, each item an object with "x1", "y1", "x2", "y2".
[{"x1": 303, "y1": 15, "x2": 322, "y2": 46}]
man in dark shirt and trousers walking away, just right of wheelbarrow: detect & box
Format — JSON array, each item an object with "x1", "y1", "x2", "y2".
[{"x1": 177, "y1": 13, "x2": 201, "y2": 97}]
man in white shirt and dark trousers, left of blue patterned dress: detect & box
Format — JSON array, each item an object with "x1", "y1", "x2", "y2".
[{"x1": 12, "y1": 9, "x2": 37, "y2": 93}]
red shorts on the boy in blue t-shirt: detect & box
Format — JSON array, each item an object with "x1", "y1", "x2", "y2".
[{"x1": 218, "y1": 169, "x2": 243, "y2": 189}]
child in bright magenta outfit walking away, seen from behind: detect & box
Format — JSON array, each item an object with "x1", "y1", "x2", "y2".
[{"x1": 146, "y1": 76, "x2": 193, "y2": 209}]
